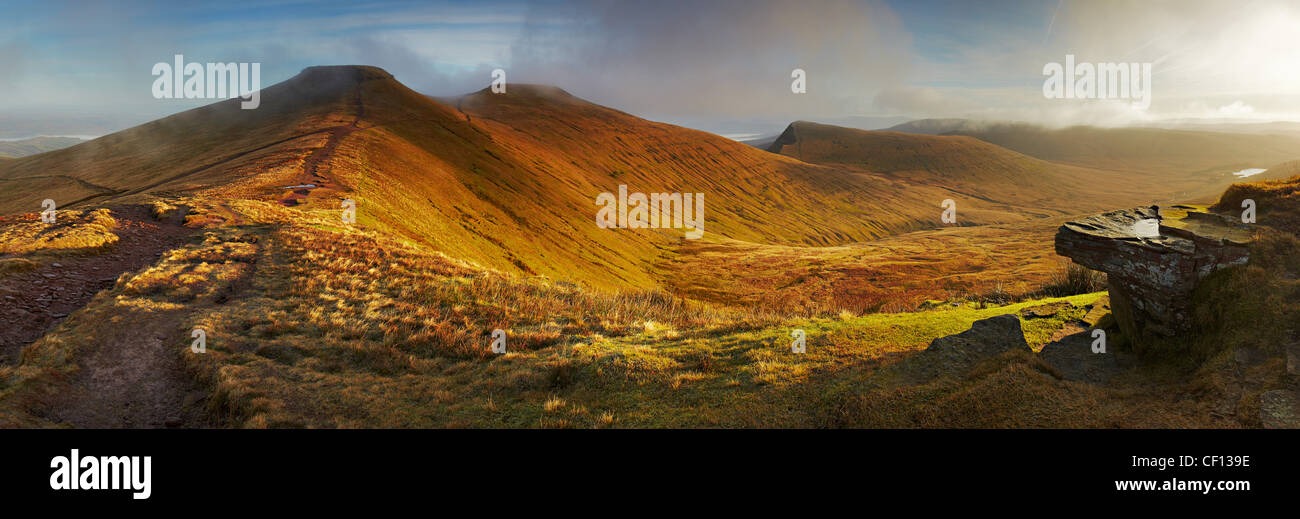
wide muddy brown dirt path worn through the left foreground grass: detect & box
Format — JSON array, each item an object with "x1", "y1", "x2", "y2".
[{"x1": 0, "y1": 206, "x2": 204, "y2": 428}]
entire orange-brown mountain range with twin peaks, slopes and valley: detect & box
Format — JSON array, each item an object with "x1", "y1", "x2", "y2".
[{"x1": 0, "y1": 66, "x2": 1284, "y2": 312}]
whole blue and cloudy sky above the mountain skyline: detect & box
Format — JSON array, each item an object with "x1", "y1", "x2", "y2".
[{"x1": 0, "y1": 0, "x2": 1300, "y2": 138}]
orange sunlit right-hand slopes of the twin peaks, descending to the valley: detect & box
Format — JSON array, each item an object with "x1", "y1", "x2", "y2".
[{"x1": 334, "y1": 81, "x2": 1040, "y2": 289}]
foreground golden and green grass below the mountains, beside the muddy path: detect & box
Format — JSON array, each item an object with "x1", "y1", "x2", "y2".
[{"x1": 0, "y1": 192, "x2": 1284, "y2": 428}]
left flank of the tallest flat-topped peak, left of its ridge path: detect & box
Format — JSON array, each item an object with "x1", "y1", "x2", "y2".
[{"x1": 0, "y1": 68, "x2": 377, "y2": 215}]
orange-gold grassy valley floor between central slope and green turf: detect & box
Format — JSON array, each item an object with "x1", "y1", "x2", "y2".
[{"x1": 662, "y1": 219, "x2": 1071, "y2": 315}]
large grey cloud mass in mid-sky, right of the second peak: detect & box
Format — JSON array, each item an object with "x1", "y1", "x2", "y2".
[{"x1": 508, "y1": 0, "x2": 910, "y2": 118}]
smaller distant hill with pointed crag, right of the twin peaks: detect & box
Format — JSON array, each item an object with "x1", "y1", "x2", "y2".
[{"x1": 768, "y1": 121, "x2": 1162, "y2": 216}]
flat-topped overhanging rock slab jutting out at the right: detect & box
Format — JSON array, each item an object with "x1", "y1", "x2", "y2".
[{"x1": 1056, "y1": 206, "x2": 1253, "y2": 346}]
